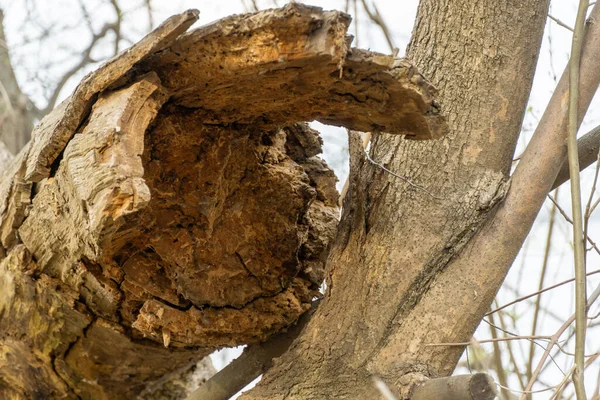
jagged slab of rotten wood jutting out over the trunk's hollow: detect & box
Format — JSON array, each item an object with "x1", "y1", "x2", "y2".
[{"x1": 140, "y1": 4, "x2": 446, "y2": 139}]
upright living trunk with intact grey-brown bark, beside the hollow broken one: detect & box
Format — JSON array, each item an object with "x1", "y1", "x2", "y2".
[{"x1": 243, "y1": 0, "x2": 548, "y2": 399}]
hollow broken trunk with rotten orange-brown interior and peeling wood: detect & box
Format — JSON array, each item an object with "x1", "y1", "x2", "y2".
[{"x1": 0, "y1": 4, "x2": 446, "y2": 399}]
